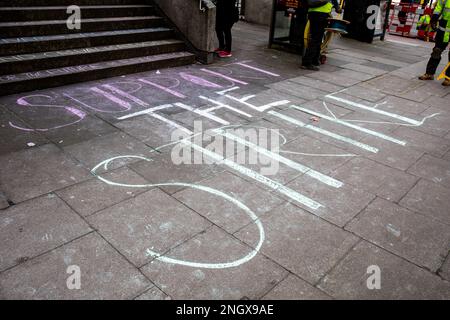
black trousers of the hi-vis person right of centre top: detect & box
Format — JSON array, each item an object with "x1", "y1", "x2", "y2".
[{"x1": 302, "y1": 12, "x2": 330, "y2": 66}]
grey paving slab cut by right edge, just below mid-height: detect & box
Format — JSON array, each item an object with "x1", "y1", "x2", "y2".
[{"x1": 400, "y1": 179, "x2": 450, "y2": 224}]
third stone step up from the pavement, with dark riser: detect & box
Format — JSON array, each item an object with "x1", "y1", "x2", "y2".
[{"x1": 0, "y1": 27, "x2": 175, "y2": 56}]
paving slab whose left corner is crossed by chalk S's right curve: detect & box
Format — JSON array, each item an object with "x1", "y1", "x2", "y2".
[{"x1": 236, "y1": 204, "x2": 358, "y2": 283}]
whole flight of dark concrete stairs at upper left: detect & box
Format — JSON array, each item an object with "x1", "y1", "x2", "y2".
[{"x1": 0, "y1": 0, "x2": 195, "y2": 95}]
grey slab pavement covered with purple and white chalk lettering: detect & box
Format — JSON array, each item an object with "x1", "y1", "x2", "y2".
[{"x1": 0, "y1": 22, "x2": 450, "y2": 299}]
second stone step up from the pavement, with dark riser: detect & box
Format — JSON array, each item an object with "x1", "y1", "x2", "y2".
[{"x1": 0, "y1": 39, "x2": 186, "y2": 75}]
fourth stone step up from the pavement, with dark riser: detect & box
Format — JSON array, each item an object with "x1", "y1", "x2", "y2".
[{"x1": 0, "y1": 16, "x2": 164, "y2": 38}]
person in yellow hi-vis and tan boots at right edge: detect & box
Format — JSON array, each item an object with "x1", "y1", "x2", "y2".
[{"x1": 419, "y1": 0, "x2": 450, "y2": 87}]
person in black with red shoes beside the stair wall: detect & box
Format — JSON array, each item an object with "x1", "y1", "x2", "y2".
[{"x1": 215, "y1": 0, "x2": 239, "y2": 58}]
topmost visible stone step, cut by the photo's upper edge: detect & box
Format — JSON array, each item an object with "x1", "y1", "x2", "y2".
[{"x1": 0, "y1": 0, "x2": 149, "y2": 7}]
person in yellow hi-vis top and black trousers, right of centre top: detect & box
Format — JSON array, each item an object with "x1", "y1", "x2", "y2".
[{"x1": 301, "y1": 0, "x2": 341, "y2": 71}]
